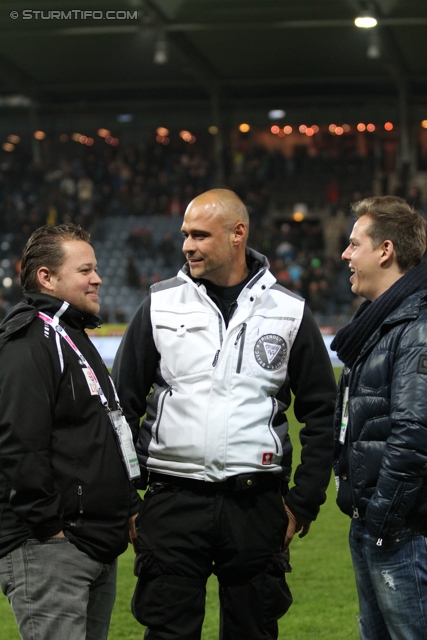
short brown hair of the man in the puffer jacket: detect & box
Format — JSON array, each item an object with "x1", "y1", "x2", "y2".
[{"x1": 352, "y1": 196, "x2": 426, "y2": 273}]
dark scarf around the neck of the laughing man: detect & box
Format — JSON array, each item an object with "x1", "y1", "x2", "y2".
[{"x1": 331, "y1": 261, "x2": 427, "y2": 369}]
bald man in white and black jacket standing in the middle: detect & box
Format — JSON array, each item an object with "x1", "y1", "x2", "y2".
[{"x1": 113, "y1": 189, "x2": 335, "y2": 640}]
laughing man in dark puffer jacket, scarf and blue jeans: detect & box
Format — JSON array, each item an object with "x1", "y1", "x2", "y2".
[{"x1": 332, "y1": 196, "x2": 427, "y2": 640}]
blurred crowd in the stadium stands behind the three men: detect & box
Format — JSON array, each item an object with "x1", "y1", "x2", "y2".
[{"x1": 0, "y1": 131, "x2": 424, "y2": 328}]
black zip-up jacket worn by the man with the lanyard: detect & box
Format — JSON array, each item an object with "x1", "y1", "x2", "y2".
[{"x1": 0, "y1": 293, "x2": 139, "y2": 562}]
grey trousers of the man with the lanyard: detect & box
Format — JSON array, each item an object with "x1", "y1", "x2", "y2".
[{"x1": 0, "y1": 538, "x2": 117, "y2": 640}]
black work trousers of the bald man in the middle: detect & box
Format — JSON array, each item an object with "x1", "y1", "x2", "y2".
[{"x1": 132, "y1": 473, "x2": 292, "y2": 640}]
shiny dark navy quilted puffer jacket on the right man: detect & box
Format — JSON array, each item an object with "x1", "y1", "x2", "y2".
[{"x1": 335, "y1": 290, "x2": 427, "y2": 544}]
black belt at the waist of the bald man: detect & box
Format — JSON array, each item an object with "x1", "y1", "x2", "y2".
[{"x1": 149, "y1": 471, "x2": 281, "y2": 494}]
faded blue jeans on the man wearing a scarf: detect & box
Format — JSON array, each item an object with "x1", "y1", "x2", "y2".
[{"x1": 350, "y1": 518, "x2": 427, "y2": 640}]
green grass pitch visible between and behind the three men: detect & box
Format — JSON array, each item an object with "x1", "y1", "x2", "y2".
[{"x1": 0, "y1": 368, "x2": 359, "y2": 640}]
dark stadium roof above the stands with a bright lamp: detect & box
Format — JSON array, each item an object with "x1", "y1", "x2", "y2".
[{"x1": 0, "y1": 0, "x2": 427, "y2": 126}]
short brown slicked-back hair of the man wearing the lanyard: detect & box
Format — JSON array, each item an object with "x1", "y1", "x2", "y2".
[{"x1": 20, "y1": 222, "x2": 90, "y2": 292}]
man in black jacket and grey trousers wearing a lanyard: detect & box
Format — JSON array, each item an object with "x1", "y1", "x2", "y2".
[{"x1": 0, "y1": 224, "x2": 139, "y2": 640}]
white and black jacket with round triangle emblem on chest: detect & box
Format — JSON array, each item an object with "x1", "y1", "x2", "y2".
[{"x1": 113, "y1": 249, "x2": 335, "y2": 519}]
